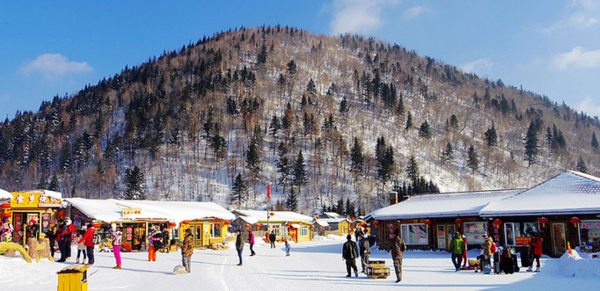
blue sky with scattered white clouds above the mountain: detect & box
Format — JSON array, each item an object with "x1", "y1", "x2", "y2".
[{"x1": 0, "y1": 0, "x2": 600, "y2": 119}]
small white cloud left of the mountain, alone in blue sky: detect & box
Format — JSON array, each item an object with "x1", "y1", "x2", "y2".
[{"x1": 21, "y1": 53, "x2": 94, "y2": 79}]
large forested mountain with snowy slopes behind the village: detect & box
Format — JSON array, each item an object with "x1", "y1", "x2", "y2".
[{"x1": 0, "y1": 26, "x2": 600, "y2": 214}]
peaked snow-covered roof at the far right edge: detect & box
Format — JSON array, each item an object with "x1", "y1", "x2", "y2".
[{"x1": 480, "y1": 171, "x2": 600, "y2": 216}]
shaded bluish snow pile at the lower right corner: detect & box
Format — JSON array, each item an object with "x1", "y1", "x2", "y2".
[{"x1": 542, "y1": 250, "x2": 600, "y2": 278}]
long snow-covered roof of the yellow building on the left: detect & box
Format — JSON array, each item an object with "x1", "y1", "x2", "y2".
[{"x1": 66, "y1": 198, "x2": 235, "y2": 223}]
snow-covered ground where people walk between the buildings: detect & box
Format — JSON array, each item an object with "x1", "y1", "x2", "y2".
[{"x1": 0, "y1": 238, "x2": 600, "y2": 291}]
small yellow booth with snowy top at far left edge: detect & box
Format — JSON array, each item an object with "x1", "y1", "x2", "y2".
[{"x1": 0, "y1": 190, "x2": 62, "y2": 245}]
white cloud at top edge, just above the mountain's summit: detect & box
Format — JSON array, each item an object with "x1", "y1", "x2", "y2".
[{"x1": 331, "y1": 0, "x2": 398, "y2": 34}]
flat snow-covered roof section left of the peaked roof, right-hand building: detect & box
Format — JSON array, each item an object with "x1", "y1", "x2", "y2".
[{"x1": 365, "y1": 189, "x2": 523, "y2": 220}]
